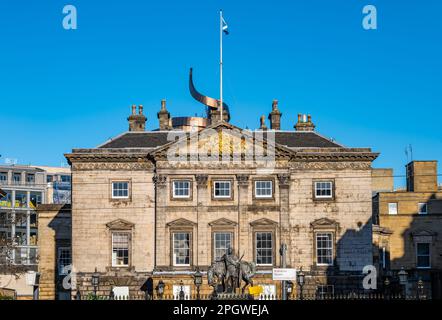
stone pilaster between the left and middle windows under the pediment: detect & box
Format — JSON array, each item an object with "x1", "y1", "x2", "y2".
[{"x1": 194, "y1": 174, "x2": 212, "y2": 267}]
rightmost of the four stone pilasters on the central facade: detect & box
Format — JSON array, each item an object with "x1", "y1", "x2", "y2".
[{"x1": 277, "y1": 173, "x2": 294, "y2": 267}]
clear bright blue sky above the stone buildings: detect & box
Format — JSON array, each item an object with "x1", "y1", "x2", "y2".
[{"x1": 0, "y1": 0, "x2": 442, "y2": 184}]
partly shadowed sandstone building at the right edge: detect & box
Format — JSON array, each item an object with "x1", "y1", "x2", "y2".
[{"x1": 373, "y1": 161, "x2": 442, "y2": 299}]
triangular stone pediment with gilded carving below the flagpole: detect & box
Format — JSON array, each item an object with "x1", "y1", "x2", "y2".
[{"x1": 151, "y1": 122, "x2": 294, "y2": 160}]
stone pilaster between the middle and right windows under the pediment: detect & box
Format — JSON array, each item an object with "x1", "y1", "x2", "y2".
[{"x1": 236, "y1": 174, "x2": 249, "y2": 261}]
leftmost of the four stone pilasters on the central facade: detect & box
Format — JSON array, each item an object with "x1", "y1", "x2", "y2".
[{"x1": 152, "y1": 174, "x2": 169, "y2": 268}]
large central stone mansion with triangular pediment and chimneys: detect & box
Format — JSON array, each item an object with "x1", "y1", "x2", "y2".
[{"x1": 60, "y1": 101, "x2": 377, "y2": 295}]
